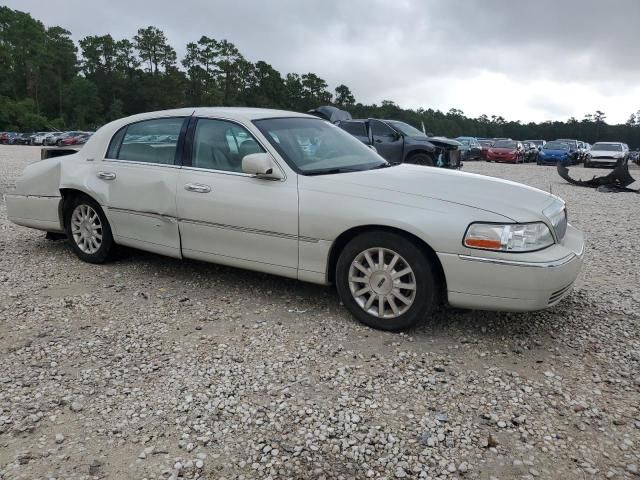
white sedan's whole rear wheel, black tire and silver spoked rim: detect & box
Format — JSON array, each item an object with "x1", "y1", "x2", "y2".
[{"x1": 65, "y1": 195, "x2": 115, "y2": 263}]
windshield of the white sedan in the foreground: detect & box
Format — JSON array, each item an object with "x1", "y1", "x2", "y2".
[{"x1": 253, "y1": 118, "x2": 388, "y2": 175}]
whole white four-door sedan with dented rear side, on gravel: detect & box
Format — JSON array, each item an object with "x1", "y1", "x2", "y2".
[{"x1": 6, "y1": 108, "x2": 584, "y2": 330}]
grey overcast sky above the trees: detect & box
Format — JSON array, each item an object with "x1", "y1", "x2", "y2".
[{"x1": 2, "y1": 0, "x2": 640, "y2": 123}]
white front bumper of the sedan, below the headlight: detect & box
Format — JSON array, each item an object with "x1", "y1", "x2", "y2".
[{"x1": 438, "y1": 225, "x2": 584, "y2": 312}]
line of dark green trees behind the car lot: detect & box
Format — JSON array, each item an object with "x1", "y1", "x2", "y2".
[{"x1": 0, "y1": 6, "x2": 640, "y2": 147}]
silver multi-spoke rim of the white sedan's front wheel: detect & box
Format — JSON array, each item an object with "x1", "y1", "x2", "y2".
[{"x1": 349, "y1": 247, "x2": 416, "y2": 318}]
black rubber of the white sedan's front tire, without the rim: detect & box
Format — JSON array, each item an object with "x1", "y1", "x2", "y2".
[{"x1": 335, "y1": 231, "x2": 440, "y2": 331}]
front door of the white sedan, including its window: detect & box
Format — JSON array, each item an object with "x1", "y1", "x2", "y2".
[{"x1": 177, "y1": 118, "x2": 298, "y2": 278}]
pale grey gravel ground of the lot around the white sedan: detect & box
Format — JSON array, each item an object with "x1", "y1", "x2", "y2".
[{"x1": 0, "y1": 147, "x2": 640, "y2": 480}]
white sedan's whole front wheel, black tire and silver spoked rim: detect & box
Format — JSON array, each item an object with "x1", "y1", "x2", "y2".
[{"x1": 336, "y1": 232, "x2": 438, "y2": 331}]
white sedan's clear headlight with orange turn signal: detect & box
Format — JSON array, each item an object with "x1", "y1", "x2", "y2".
[{"x1": 462, "y1": 222, "x2": 555, "y2": 252}]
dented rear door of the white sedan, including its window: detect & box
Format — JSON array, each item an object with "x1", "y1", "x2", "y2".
[{"x1": 96, "y1": 117, "x2": 188, "y2": 257}]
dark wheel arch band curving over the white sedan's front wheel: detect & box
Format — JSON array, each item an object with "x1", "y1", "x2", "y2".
[{"x1": 326, "y1": 224, "x2": 447, "y2": 299}]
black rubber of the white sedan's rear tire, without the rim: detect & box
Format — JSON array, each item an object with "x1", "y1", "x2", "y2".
[{"x1": 64, "y1": 195, "x2": 115, "y2": 263}]
